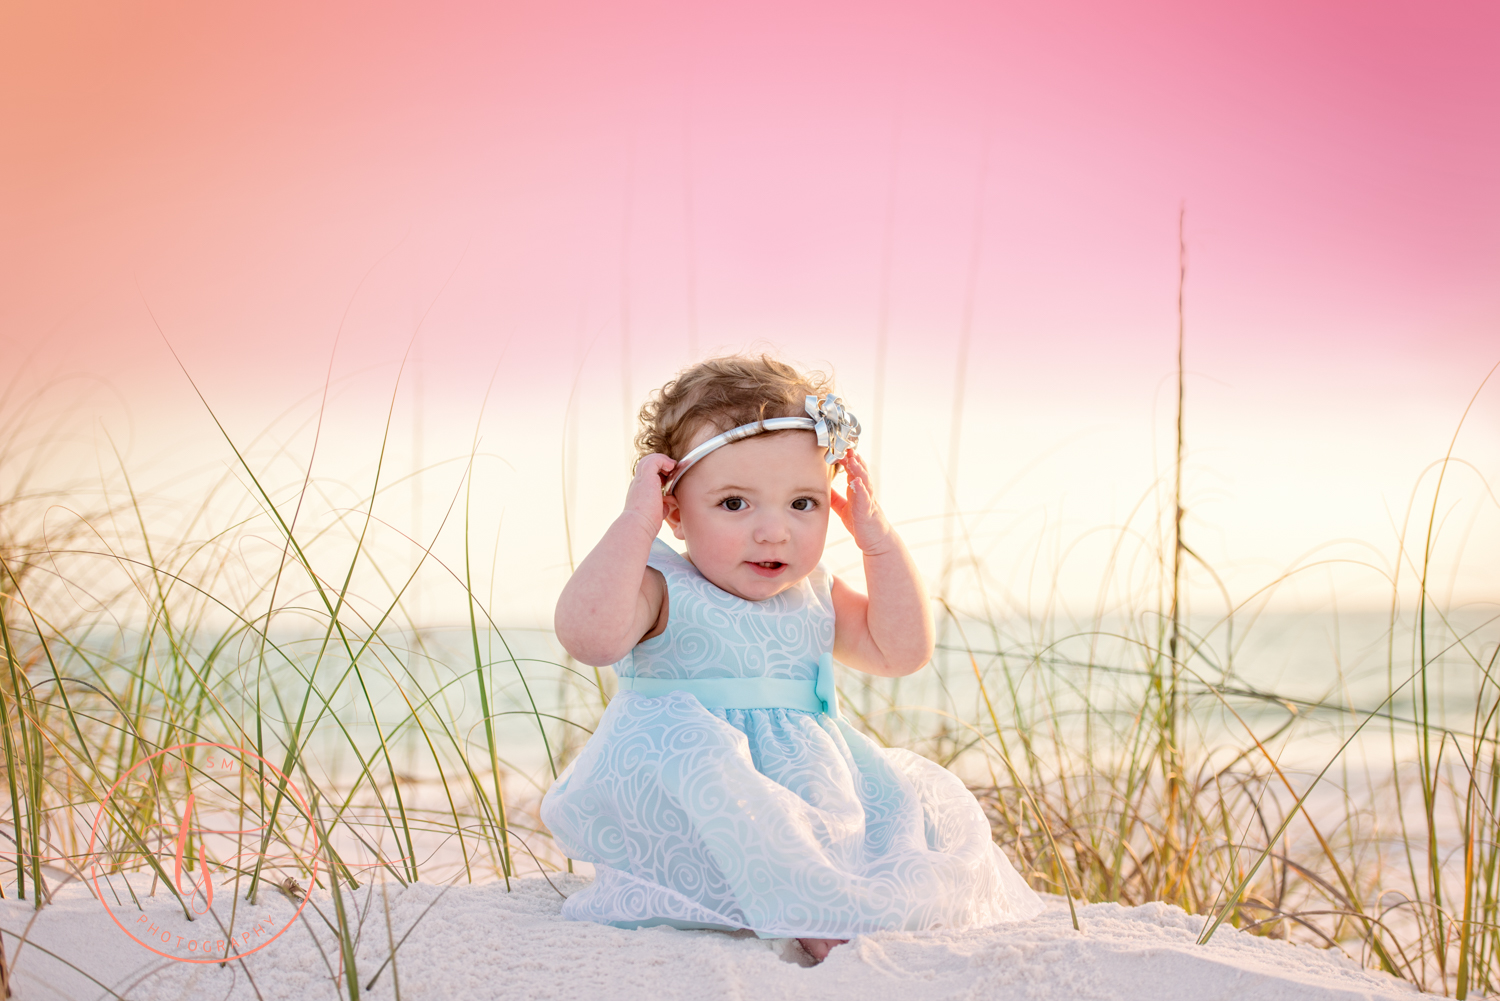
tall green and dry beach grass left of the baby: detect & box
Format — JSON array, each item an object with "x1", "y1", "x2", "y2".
[{"x1": 0, "y1": 379, "x2": 578, "y2": 998}]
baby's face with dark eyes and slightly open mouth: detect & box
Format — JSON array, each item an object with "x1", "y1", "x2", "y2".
[{"x1": 666, "y1": 429, "x2": 833, "y2": 602}]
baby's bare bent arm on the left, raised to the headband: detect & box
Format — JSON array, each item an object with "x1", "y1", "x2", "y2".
[{"x1": 552, "y1": 455, "x2": 675, "y2": 668}]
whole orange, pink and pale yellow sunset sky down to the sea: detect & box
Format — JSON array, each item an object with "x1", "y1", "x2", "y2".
[{"x1": 0, "y1": 0, "x2": 1500, "y2": 626}]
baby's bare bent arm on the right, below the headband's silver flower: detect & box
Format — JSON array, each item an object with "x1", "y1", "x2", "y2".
[{"x1": 833, "y1": 453, "x2": 936, "y2": 677}]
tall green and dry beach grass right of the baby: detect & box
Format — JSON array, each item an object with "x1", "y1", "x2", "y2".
[{"x1": 866, "y1": 358, "x2": 1500, "y2": 998}]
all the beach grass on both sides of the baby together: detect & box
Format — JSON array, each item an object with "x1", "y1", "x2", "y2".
[{"x1": 0, "y1": 370, "x2": 1500, "y2": 998}]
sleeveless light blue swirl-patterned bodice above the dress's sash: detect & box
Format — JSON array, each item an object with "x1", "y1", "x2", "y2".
[{"x1": 615, "y1": 539, "x2": 834, "y2": 681}]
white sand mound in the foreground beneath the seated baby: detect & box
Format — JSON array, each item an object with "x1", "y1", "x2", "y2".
[{"x1": 0, "y1": 876, "x2": 1419, "y2": 1001}]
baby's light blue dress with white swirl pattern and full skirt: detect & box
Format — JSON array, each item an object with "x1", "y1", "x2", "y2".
[{"x1": 542, "y1": 540, "x2": 1041, "y2": 938}]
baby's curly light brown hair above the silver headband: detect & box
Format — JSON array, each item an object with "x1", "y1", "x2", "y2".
[{"x1": 636, "y1": 354, "x2": 833, "y2": 462}]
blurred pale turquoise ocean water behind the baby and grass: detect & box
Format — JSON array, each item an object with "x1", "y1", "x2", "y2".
[{"x1": 52, "y1": 609, "x2": 1500, "y2": 795}]
